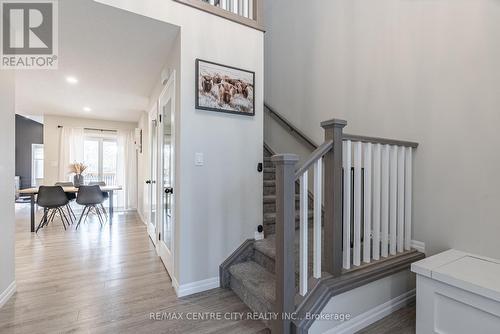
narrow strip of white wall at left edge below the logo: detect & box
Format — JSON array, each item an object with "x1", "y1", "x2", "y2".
[{"x1": 0, "y1": 70, "x2": 16, "y2": 307}]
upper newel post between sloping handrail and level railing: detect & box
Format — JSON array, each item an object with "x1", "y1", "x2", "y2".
[{"x1": 321, "y1": 119, "x2": 347, "y2": 277}]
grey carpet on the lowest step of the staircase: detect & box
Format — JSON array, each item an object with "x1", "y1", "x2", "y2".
[{"x1": 229, "y1": 261, "x2": 276, "y2": 303}]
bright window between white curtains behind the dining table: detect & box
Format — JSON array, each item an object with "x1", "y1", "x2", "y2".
[{"x1": 83, "y1": 136, "x2": 118, "y2": 185}]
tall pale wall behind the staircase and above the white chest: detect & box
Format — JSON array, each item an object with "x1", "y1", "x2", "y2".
[{"x1": 265, "y1": 0, "x2": 500, "y2": 258}]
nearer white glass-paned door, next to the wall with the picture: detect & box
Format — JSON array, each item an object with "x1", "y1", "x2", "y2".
[{"x1": 157, "y1": 73, "x2": 175, "y2": 276}]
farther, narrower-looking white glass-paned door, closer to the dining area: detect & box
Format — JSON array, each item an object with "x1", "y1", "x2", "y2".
[{"x1": 146, "y1": 107, "x2": 158, "y2": 245}]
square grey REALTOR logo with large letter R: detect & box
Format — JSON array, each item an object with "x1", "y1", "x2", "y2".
[{"x1": 0, "y1": 0, "x2": 58, "y2": 69}]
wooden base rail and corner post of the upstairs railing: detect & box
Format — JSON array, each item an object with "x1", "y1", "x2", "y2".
[{"x1": 174, "y1": 0, "x2": 265, "y2": 32}]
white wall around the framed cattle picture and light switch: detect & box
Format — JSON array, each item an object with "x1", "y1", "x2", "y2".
[{"x1": 95, "y1": 0, "x2": 264, "y2": 285}]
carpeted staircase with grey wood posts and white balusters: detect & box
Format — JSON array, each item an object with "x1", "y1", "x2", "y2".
[{"x1": 220, "y1": 117, "x2": 424, "y2": 334}]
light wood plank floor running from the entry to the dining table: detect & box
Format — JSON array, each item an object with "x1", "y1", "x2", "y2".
[{"x1": 0, "y1": 204, "x2": 266, "y2": 334}]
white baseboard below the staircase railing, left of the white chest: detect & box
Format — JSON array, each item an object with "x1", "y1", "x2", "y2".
[{"x1": 326, "y1": 289, "x2": 415, "y2": 334}]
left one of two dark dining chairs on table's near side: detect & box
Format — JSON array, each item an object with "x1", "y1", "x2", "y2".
[{"x1": 36, "y1": 186, "x2": 70, "y2": 233}]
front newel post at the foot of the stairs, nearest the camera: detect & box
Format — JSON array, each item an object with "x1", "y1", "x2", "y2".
[{"x1": 271, "y1": 154, "x2": 299, "y2": 334}]
